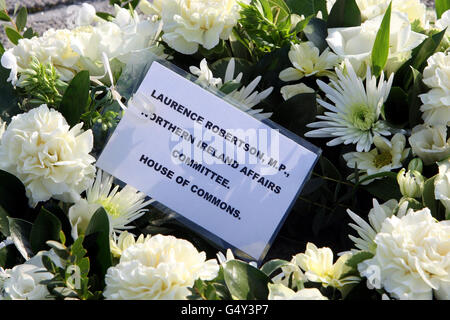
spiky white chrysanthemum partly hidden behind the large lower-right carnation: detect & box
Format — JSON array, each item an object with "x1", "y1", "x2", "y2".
[{"x1": 347, "y1": 199, "x2": 401, "y2": 253}]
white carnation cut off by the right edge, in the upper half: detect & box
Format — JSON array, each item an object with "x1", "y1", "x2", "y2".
[{"x1": 420, "y1": 52, "x2": 450, "y2": 126}]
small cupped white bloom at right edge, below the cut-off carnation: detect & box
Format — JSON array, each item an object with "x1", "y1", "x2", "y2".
[{"x1": 409, "y1": 125, "x2": 450, "y2": 165}]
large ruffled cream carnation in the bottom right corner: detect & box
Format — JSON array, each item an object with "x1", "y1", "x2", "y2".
[{"x1": 358, "y1": 208, "x2": 450, "y2": 300}]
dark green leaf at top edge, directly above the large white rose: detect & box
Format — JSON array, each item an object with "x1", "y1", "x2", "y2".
[{"x1": 328, "y1": 0, "x2": 361, "y2": 28}]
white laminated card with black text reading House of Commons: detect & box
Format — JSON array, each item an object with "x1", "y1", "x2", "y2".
[{"x1": 97, "y1": 61, "x2": 318, "y2": 260}]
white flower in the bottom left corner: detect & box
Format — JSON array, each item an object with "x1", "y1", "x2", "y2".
[{"x1": 3, "y1": 264, "x2": 53, "y2": 300}]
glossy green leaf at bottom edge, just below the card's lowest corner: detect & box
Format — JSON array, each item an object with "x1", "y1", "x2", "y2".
[{"x1": 224, "y1": 260, "x2": 270, "y2": 300}]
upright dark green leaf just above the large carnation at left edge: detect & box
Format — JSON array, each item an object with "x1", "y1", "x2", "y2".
[{"x1": 59, "y1": 71, "x2": 90, "y2": 126}]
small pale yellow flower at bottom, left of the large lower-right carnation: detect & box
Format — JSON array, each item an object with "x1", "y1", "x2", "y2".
[{"x1": 293, "y1": 243, "x2": 360, "y2": 289}]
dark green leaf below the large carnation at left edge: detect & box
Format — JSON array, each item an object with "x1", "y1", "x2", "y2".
[{"x1": 30, "y1": 208, "x2": 61, "y2": 253}]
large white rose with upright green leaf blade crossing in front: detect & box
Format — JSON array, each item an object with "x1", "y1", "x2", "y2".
[{"x1": 326, "y1": 12, "x2": 427, "y2": 74}]
